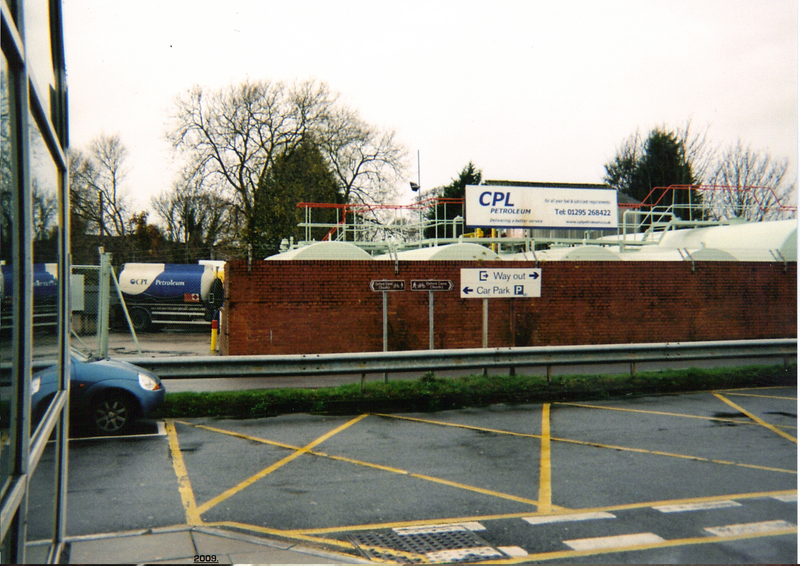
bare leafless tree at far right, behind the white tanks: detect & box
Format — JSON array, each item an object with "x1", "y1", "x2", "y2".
[{"x1": 705, "y1": 140, "x2": 797, "y2": 221}]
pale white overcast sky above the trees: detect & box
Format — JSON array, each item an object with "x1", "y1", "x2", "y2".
[{"x1": 63, "y1": 0, "x2": 798, "y2": 213}]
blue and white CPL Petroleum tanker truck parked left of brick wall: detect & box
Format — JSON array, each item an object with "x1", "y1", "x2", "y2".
[{"x1": 119, "y1": 261, "x2": 225, "y2": 332}]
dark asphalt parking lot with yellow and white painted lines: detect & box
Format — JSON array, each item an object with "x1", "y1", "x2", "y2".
[{"x1": 30, "y1": 387, "x2": 797, "y2": 563}]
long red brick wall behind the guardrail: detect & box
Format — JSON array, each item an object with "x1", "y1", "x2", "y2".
[{"x1": 220, "y1": 261, "x2": 797, "y2": 355}]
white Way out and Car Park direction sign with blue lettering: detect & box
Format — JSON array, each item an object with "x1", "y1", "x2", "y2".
[{"x1": 461, "y1": 267, "x2": 542, "y2": 299}]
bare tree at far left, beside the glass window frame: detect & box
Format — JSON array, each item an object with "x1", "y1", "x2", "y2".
[{"x1": 69, "y1": 134, "x2": 131, "y2": 236}]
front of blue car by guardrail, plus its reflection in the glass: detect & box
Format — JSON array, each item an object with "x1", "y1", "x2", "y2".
[{"x1": 31, "y1": 350, "x2": 165, "y2": 435}]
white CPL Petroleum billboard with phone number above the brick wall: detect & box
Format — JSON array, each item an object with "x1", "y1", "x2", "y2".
[{"x1": 465, "y1": 185, "x2": 617, "y2": 230}]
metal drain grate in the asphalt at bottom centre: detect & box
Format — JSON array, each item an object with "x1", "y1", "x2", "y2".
[{"x1": 349, "y1": 525, "x2": 506, "y2": 564}]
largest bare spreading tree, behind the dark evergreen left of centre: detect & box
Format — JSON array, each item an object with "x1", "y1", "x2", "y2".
[{"x1": 169, "y1": 81, "x2": 401, "y2": 248}]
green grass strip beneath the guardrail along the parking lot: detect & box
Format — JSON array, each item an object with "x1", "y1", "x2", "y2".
[{"x1": 153, "y1": 364, "x2": 797, "y2": 419}]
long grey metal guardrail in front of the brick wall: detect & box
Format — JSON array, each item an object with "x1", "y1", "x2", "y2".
[{"x1": 127, "y1": 339, "x2": 797, "y2": 379}]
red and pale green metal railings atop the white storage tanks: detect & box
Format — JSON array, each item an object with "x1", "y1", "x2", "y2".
[{"x1": 286, "y1": 185, "x2": 797, "y2": 254}]
